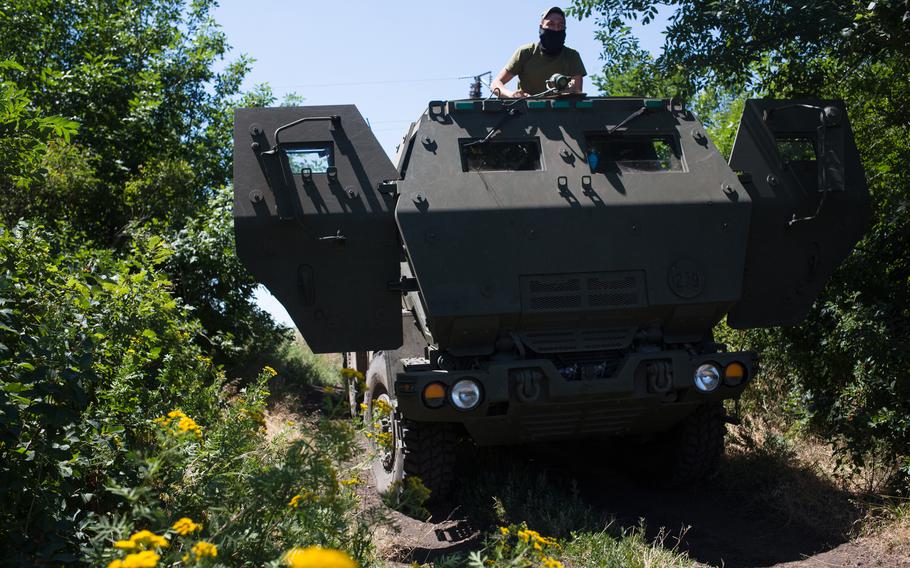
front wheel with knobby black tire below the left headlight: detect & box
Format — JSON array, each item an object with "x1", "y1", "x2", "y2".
[{"x1": 364, "y1": 354, "x2": 457, "y2": 502}]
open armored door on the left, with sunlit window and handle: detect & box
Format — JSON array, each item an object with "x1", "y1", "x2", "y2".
[{"x1": 234, "y1": 105, "x2": 402, "y2": 353}]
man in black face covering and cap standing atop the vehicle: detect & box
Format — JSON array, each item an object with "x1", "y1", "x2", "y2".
[{"x1": 490, "y1": 6, "x2": 587, "y2": 99}]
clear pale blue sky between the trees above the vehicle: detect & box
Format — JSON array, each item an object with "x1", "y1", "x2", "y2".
[{"x1": 213, "y1": 0, "x2": 666, "y2": 325}]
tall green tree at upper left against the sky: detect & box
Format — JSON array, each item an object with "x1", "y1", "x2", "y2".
[{"x1": 0, "y1": 0, "x2": 276, "y2": 360}]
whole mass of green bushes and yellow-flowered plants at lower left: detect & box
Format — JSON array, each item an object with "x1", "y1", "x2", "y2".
[{"x1": 0, "y1": 224, "x2": 378, "y2": 565}]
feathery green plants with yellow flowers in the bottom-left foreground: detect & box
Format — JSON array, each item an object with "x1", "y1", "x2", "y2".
[{"x1": 83, "y1": 370, "x2": 374, "y2": 566}]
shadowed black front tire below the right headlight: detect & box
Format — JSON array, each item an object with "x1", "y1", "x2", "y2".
[{"x1": 669, "y1": 402, "x2": 726, "y2": 487}]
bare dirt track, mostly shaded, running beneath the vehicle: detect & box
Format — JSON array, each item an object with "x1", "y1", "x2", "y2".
[{"x1": 370, "y1": 446, "x2": 910, "y2": 568}]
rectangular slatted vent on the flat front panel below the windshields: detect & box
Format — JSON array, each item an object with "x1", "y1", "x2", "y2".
[{"x1": 521, "y1": 270, "x2": 647, "y2": 313}]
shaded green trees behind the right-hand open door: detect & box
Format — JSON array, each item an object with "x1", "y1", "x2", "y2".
[{"x1": 573, "y1": 0, "x2": 910, "y2": 487}]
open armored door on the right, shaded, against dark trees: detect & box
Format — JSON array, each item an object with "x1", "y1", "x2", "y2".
[{"x1": 727, "y1": 99, "x2": 870, "y2": 328}]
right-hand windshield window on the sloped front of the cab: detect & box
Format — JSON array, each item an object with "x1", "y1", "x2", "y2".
[{"x1": 586, "y1": 134, "x2": 684, "y2": 173}]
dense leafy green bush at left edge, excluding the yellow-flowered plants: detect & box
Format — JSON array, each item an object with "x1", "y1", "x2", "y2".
[{"x1": 0, "y1": 225, "x2": 221, "y2": 560}]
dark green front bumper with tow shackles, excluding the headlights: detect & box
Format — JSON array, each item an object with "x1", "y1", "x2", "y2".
[{"x1": 395, "y1": 351, "x2": 757, "y2": 445}]
